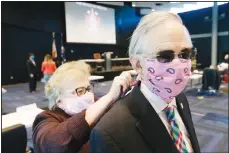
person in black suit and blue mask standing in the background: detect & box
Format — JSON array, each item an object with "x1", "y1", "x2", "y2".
[{"x1": 26, "y1": 53, "x2": 38, "y2": 93}]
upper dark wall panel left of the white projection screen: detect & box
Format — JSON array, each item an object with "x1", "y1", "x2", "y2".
[{"x1": 2, "y1": 1, "x2": 64, "y2": 33}]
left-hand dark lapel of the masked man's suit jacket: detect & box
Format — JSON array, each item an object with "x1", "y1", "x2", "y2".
[{"x1": 128, "y1": 83, "x2": 178, "y2": 153}]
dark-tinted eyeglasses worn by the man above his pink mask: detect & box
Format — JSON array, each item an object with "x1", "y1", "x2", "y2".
[{"x1": 143, "y1": 48, "x2": 195, "y2": 63}]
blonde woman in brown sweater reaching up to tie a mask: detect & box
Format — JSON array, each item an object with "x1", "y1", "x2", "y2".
[{"x1": 33, "y1": 61, "x2": 131, "y2": 153}]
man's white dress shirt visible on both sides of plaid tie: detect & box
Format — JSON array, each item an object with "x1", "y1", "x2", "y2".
[{"x1": 140, "y1": 83, "x2": 193, "y2": 152}]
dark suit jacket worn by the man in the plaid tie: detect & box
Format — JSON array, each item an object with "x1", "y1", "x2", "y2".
[{"x1": 90, "y1": 82, "x2": 200, "y2": 153}]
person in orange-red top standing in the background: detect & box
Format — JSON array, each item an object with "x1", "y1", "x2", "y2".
[{"x1": 41, "y1": 54, "x2": 56, "y2": 84}]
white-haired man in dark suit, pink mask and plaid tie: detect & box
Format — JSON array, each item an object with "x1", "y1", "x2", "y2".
[{"x1": 90, "y1": 12, "x2": 200, "y2": 153}]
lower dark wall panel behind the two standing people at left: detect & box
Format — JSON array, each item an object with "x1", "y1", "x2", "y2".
[{"x1": 1, "y1": 24, "x2": 60, "y2": 84}]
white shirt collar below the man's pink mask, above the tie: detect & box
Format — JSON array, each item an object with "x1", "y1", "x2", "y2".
[{"x1": 140, "y1": 83, "x2": 176, "y2": 114}]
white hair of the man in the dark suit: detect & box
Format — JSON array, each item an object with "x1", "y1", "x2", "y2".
[{"x1": 128, "y1": 12, "x2": 183, "y2": 57}]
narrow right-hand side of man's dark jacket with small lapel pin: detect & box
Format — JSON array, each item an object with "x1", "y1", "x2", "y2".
[{"x1": 176, "y1": 93, "x2": 200, "y2": 153}]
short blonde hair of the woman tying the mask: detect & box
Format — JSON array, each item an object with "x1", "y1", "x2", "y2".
[{"x1": 45, "y1": 61, "x2": 90, "y2": 110}]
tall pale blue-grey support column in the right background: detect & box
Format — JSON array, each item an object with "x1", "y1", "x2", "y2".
[{"x1": 211, "y1": 2, "x2": 218, "y2": 66}]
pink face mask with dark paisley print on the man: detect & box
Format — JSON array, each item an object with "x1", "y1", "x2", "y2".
[{"x1": 142, "y1": 58, "x2": 191, "y2": 103}]
